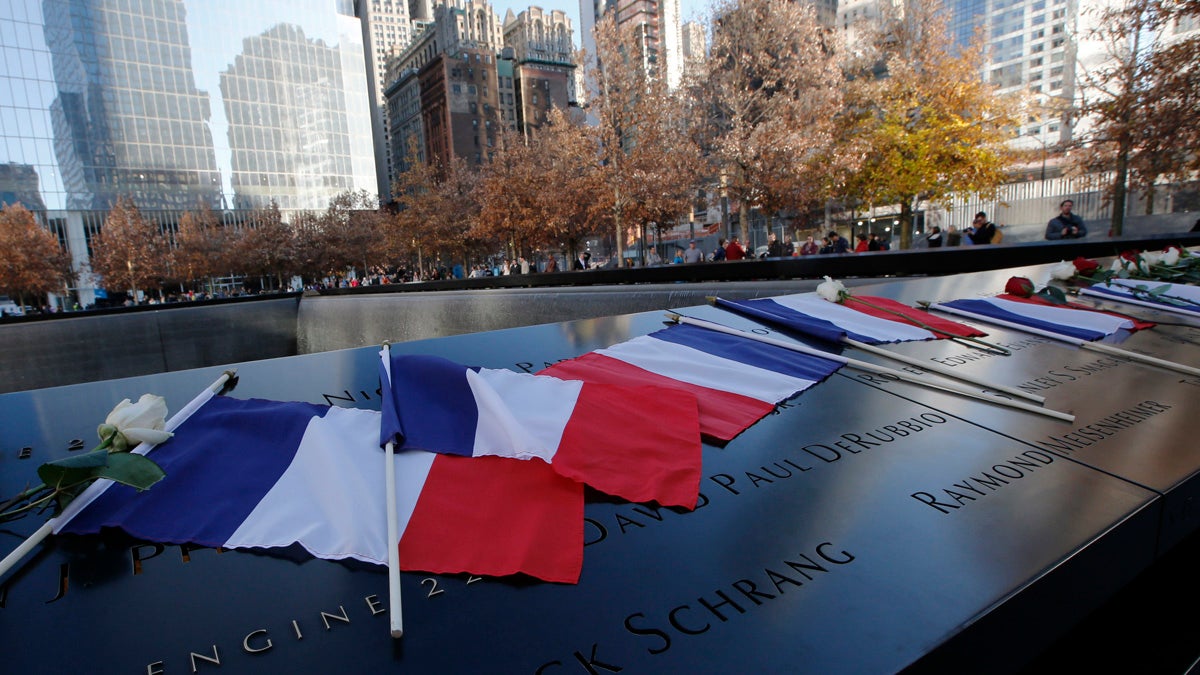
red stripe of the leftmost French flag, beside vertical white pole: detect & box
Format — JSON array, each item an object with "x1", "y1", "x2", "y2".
[{"x1": 400, "y1": 455, "x2": 583, "y2": 584}]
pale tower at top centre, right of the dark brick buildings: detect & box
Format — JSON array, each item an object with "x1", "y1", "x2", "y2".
[{"x1": 580, "y1": 0, "x2": 684, "y2": 89}]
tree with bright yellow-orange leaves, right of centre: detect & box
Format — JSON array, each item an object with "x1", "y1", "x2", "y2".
[{"x1": 842, "y1": 0, "x2": 1019, "y2": 249}]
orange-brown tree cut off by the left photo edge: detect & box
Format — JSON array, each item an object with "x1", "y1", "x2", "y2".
[{"x1": 0, "y1": 204, "x2": 71, "y2": 306}]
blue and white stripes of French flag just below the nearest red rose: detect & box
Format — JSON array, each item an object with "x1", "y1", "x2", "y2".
[{"x1": 934, "y1": 297, "x2": 1135, "y2": 342}]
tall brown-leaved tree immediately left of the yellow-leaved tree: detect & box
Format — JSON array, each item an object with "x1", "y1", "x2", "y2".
[{"x1": 700, "y1": 0, "x2": 847, "y2": 240}]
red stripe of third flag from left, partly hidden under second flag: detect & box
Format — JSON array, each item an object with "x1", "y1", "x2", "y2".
[{"x1": 538, "y1": 352, "x2": 775, "y2": 441}]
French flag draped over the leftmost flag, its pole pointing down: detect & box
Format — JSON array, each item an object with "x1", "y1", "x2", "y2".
[{"x1": 379, "y1": 350, "x2": 702, "y2": 508}]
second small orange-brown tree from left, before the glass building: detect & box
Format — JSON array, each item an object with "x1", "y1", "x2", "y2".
[{"x1": 91, "y1": 197, "x2": 169, "y2": 299}]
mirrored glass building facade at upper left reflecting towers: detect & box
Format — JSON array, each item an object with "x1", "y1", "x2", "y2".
[{"x1": 0, "y1": 0, "x2": 378, "y2": 300}]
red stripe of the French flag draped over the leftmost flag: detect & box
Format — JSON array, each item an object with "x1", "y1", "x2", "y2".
[{"x1": 553, "y1": 382, "x2": 701, "y2": 508}]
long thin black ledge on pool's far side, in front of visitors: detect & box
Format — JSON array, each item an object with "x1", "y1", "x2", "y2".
[{"x1": 319, "y1": 232, "x2": 1200, "y2": 295}]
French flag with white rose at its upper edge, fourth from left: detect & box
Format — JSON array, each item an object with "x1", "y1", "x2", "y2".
[{"x1": 715, "y1": 293, "x2": 985, "y2": 345}]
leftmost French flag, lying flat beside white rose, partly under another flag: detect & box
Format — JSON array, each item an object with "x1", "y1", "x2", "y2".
[{"x1": 55, "y1": 395, "x2": 583, "y2": 583}]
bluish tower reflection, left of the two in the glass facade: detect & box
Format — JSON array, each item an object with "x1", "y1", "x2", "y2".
[{"x1": 43, "y1": 0, "x2": 220, "y2": 209}]
